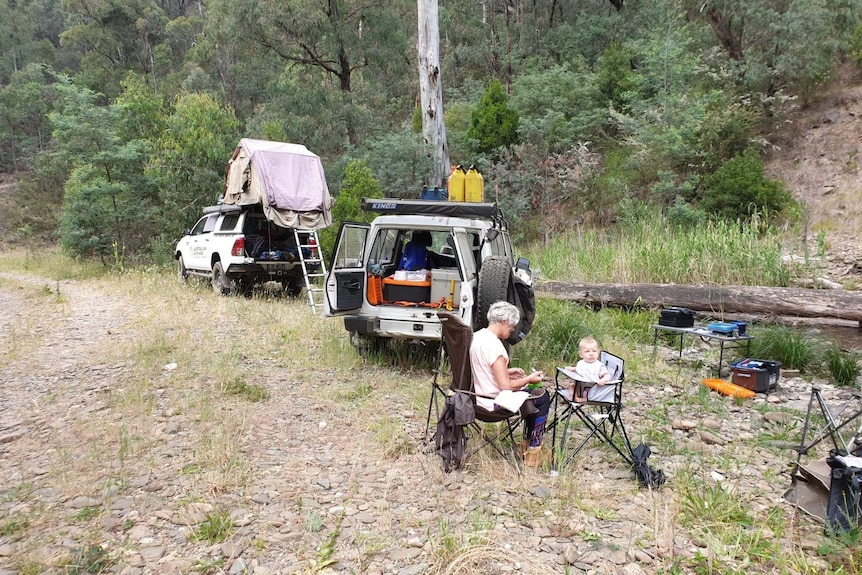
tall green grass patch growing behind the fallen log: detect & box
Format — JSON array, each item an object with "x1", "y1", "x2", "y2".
[{"x1": 531, "y1": 209, "x2": 790, "y2": 286}]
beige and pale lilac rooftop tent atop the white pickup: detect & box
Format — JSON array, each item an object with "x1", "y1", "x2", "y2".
[{"x1": 224, "y1": 138, "x2": 332, "y2": 229}]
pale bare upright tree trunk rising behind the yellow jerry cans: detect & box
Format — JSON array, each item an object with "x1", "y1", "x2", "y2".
[{"x1": 416, "y1": 0, "x2": 450, "y2": 187}]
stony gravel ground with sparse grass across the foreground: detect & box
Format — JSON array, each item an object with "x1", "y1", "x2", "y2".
[{"x1": 0, "y1": 274, "x2": 856, "y2": 575}]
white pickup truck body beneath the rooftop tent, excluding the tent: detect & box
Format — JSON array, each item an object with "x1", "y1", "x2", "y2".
[{"x1": 174, "y1": 204, "x2": 317, "y2": 297}]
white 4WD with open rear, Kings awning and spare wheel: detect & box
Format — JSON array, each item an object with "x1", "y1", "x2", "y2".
[{"x1": 324, "y1": 199, "x2": 535, "y2": 348}]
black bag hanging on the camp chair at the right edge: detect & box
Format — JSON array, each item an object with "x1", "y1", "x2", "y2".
[{"x1": 826, "y1": 451, "x2": 862, "y2": 533}]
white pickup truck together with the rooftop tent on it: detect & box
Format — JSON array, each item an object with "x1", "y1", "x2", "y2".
[{"x1": 174, "y1": 138, "x2": 332, "y2": 296}]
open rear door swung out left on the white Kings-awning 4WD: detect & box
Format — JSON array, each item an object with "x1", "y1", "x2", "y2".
[{"x1": 324, "y1": 222, "x2": 371, "y2": 316}]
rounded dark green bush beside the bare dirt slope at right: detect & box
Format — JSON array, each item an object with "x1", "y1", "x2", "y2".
[{"x1": 701, "y1": 148, "x2": 793, "y2": 219}]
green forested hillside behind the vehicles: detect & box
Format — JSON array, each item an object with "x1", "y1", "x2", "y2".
[{"x1": 0, "y1": 0, "x2": 862, "y2": 263}]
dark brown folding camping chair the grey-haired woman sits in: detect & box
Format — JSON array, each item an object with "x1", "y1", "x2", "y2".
[{"x1": 425, "y1": 312, "x2": 521, "y2": 473}]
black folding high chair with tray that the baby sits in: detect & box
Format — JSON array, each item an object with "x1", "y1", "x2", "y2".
[{"x1": 551, "y1": 351, "x2": 634, "y2": 473}]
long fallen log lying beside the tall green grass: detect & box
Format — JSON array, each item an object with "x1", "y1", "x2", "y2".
[{"x1": 534, "y1": 281, "x2": 862, "y2": 326}]
